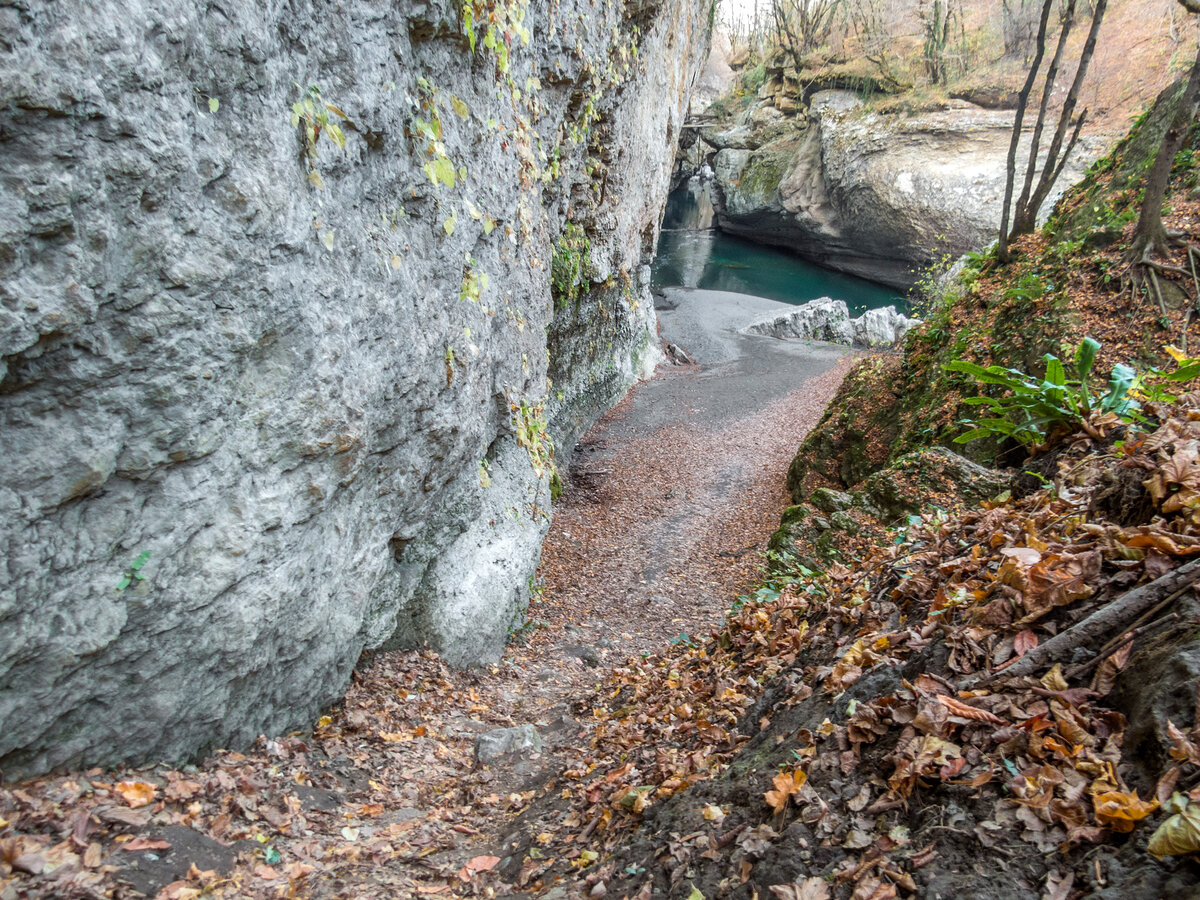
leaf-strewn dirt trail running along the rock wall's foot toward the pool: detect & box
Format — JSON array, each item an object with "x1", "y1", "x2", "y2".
[{"x1": 0, "y1": 292, "x2": 852, "y2": 900}]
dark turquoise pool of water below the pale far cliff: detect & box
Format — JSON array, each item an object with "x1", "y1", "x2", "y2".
[{"x1": 652, "y1": 182, "x2": 905, "y2": 316}]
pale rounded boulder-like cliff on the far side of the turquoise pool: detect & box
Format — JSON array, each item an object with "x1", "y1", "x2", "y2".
[{"x1": 704, "y1": 91, "x2": 1103, "y2": 288}]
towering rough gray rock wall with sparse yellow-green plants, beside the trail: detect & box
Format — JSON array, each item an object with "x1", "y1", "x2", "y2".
[{"x1": 0, "y1": 0, "x2": 707, "y2": 778}]
